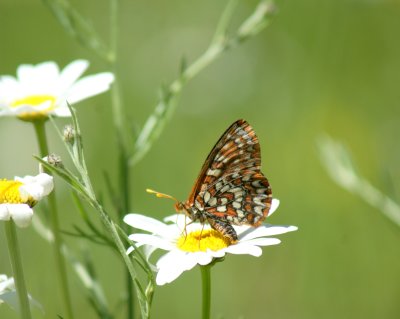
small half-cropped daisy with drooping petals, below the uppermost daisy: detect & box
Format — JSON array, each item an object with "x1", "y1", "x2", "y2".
[{"x1": 0, "y1": 173, "x2": 53, "y2": 227}]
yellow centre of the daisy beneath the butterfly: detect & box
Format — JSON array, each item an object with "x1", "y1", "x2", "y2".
[{"x1": 177, "y1": 229, "x2": 230, "y2": 253}]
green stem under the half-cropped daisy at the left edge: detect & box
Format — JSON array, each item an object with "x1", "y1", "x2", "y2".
[{"x1": 4, "y1": 220, "x2": 32, "y2": 319}]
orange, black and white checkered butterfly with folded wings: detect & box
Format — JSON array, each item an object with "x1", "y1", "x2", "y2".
[{"x1": 148, "y1": 120, "x2": 272, "y2": 243}]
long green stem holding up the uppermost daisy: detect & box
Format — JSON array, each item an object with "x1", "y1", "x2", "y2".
[{"x1": 33, "y1": 121, "x2": 73, "y2": 319}]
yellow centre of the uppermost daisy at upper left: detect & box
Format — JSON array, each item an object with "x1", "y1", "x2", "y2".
[{"x1": 11, "y1": 94, "x2": 56, "y2": 121}]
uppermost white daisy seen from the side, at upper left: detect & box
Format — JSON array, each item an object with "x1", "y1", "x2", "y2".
[{"x1": 0, "y1": 60, "x2": 114, "y2": 121}]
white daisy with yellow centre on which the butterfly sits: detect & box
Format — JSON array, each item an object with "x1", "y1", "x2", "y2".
[{"x1": 124, "y1": 199, "x2": 297, "y2": 285}]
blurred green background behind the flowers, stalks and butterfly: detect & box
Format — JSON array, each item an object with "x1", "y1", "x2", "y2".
[{"x1": 0, "y1": 0, "x2": 400, "y2": 319}]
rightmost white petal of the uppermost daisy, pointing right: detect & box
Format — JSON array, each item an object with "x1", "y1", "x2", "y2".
[{"x1": 67, "y1": 72, "x2": 114, "y2": 104}]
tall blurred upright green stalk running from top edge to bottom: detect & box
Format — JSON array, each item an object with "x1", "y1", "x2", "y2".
[{"x1": 110, "y1": 0, "x2": 135, "y2": 319}]
